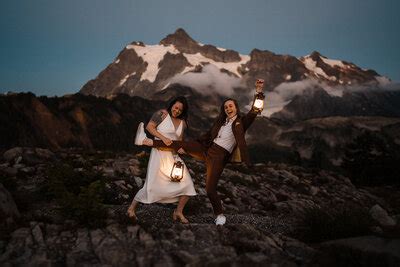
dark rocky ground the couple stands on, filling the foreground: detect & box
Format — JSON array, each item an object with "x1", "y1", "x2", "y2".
[{"x1": 0, "y1": 147, "x2": 400, "y2": 266}]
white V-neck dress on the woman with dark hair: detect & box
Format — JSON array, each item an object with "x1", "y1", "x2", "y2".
[{"x1": 135, "y1": 114, "x2": 196, "y2": 203}]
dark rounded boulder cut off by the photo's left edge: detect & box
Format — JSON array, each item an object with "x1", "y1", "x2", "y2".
[{"x1": 0, "y1": 183, "x2": 20, "y2": 226}]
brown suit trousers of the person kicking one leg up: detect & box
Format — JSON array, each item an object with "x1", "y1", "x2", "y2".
[{"x1": 153, "y1": 140, "x2": 230, "y2": 215}]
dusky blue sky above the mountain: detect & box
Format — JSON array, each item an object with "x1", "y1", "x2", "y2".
[{"x1": 0, "y1": 0, "x2": 400, "y2": 96}]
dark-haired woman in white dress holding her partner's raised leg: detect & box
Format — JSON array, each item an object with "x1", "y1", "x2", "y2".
[{"x1": 127, "y1": 96, "x2": 196, "y2": 224}]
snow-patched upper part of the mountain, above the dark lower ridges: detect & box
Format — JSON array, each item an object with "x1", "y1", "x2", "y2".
[{"x1": 80, "y1": 29, "x2": 388, "y2": 99}]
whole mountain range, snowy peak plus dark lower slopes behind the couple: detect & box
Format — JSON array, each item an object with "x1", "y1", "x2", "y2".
[{"x1": 0, "y1": 29, "x2": 400, "y2": 177}]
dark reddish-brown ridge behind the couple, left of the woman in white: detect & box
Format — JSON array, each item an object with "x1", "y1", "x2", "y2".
[{"x1": 0, "y1": 91, "x2": 211, "y2": 151}]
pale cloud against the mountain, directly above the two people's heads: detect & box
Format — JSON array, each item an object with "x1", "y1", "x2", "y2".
[{"x1": 170, "y1": 64, "x2": 241, "y2": 96}]
